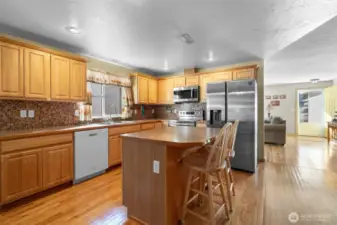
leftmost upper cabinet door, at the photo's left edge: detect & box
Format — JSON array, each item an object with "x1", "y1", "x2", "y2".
[{"x1": 0, "y1": 42, "x2": 24, "y2": 97}]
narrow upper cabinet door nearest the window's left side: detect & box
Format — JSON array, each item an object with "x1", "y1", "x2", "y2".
[{"x1": 70, "y1": 60, "x2": 87, "y2": 101}]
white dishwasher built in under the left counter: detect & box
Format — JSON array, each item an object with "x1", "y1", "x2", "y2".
[{"x1": 74, "y1": 128, "x2": 109, "y2": 184}]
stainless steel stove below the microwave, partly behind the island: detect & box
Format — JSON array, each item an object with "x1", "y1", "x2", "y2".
[{"x1": 168, "y1": 110, "x2": 203, "y2": 127}]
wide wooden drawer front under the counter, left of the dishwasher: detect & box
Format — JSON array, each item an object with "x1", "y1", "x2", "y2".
[{"x1": 0, "y1": 133, "x2": 73, "y2": 153}]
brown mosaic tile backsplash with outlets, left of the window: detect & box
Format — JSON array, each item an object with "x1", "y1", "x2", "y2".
[{"x1": 0, "y1": 100, "x2": 77, "y2": 131}]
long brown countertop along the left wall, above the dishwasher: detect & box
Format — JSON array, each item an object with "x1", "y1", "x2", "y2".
[{"x1": 0, "y1": 119, "x2": 165, "y2": 140}]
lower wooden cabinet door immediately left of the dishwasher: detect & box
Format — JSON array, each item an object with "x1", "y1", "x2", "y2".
[{"x1": 42, "y1": 144, "x2": 74, "y2": 188}]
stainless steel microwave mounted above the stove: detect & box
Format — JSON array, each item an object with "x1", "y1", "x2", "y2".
[{"x1": 173, "y1": 86, "x2": 200, "y2": 103}]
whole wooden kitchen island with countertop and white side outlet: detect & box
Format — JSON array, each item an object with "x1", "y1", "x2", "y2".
[{"x1": 121, "y1": 127, "x2": 219, "y2": 225}]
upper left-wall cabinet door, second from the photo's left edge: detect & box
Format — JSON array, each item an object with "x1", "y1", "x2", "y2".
[{"x1": 24, "y1": 48, "x2": 50, "y2": 99}]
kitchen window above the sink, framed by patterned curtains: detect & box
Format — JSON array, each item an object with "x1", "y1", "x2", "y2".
[{"x1": 88, "y1": 82, "x2": 122, "y2": 118}]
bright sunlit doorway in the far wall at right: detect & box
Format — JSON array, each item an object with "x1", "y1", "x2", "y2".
[{"x1": 296, "y1": 89, "x2": 325, "y2": 137}]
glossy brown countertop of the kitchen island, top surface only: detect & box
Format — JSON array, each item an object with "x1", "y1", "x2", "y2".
[{"x1": 121, "y1": 127, "x2": 220, "y2": 145}]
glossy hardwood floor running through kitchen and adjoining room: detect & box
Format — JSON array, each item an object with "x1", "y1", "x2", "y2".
[{"x1": 0, "y1": 137, "x2": 337, "y2": 225}]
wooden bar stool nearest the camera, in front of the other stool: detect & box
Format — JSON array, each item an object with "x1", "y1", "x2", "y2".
[{"x1": 181, "y1": 124, "x2": 232, "y2": 225}]
